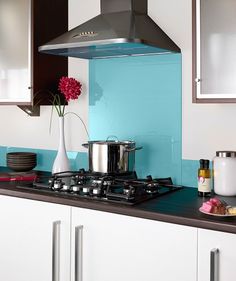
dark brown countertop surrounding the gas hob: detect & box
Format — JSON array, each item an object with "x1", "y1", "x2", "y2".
[{"x1": 0, "y1": 182, "x2": 236, "y2": 233}]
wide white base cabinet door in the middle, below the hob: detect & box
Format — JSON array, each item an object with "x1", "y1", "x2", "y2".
[{"x1": 72, "y1": 208, "x2": 197, "y2": 281}]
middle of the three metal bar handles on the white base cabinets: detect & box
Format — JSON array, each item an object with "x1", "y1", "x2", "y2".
[{"x1": 75, "y1": 225, "x2": 83, "y2": 281}]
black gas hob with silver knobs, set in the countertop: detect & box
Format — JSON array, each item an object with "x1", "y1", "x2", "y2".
[{"x1": 18, "y1": 169, "x2": 182, "y2": 205}]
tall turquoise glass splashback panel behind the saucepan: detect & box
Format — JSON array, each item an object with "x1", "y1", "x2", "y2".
[{"x1": 89, "y1": 54, "x2": 182, "y2": 183}]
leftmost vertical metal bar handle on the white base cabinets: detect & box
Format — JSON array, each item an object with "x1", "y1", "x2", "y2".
[{"x1": 52, "y1": 221, "x2": 61, "y2": 281}]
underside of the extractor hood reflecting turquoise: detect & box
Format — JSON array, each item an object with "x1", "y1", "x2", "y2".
[{"x1": 42, "y1": 43, "x2": 169, "y2": 59}]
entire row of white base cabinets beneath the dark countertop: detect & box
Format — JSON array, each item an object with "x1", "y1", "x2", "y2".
[{"x1": 4, "y1": 196, "x2": 236, "y2": 281}]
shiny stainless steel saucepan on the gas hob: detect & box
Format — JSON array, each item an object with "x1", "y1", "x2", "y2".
[{"x1": 83, "y1": 137, "x2": 142, "y2": 174}]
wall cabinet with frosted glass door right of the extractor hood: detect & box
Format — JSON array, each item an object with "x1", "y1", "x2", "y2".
[{"x1": 192, "y1": 0, "x2": 236, "y2": 102}]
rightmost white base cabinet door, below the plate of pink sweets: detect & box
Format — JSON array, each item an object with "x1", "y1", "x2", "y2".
[{"x1": 198, "y1": 229, "x2": 236, "y2": 281}]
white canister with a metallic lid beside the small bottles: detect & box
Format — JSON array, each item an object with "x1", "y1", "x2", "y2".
[{"x1": 213, "y1": 151, "x2": 236, "y2": 196}]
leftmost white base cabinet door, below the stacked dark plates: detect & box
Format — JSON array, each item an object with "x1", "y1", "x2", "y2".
[{"x1": 0, "y1": 196, "x2": 70, "y2": 281}]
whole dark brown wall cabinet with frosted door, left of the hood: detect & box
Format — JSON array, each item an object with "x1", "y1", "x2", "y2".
[{"x1": 0, "y1": 0, "x2": 68, "y2": 116}]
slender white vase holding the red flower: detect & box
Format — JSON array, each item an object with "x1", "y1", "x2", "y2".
[{"x1": 52, "y1": 117, "x2": 70, "y2": 174}]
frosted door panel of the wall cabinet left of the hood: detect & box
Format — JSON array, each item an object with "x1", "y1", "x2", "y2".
[{"x1": 0, "y1": 0, "x2": 31, "y2": 103}]
